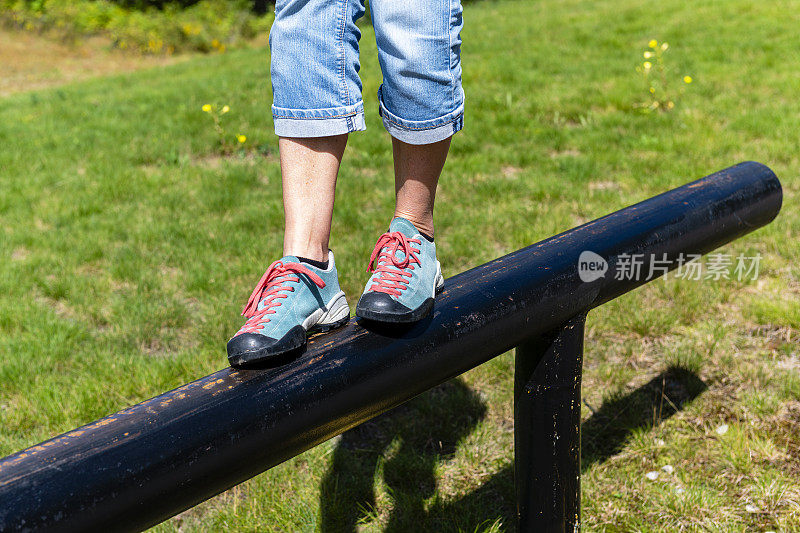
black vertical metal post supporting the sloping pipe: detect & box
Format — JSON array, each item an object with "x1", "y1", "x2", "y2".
[{"x1": 514, "y1": 312, "x2": 586, "y2": 533}]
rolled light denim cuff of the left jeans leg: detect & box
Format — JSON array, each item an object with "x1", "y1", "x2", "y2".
[{"x1": 272, "y1": 102, "x2": 367, "y2": 137}]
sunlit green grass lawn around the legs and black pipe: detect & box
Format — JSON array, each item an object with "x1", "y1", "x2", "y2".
[{"x1": 0, "y1": 0, "x2": 800, "y2": 532}]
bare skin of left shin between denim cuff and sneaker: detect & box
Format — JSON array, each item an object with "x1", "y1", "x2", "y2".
[{"x1": 278, "y1": 134, "x2": 347, "y2": 261}]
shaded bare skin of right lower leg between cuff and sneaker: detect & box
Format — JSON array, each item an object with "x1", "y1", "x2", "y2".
[{"x1": 392, "y1": 137, "x2": 450, "y2": 237}]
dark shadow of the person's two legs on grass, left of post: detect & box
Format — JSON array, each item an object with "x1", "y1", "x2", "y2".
[{"x1": 320, "y1": 378, "x2": 486, "y2": 533}]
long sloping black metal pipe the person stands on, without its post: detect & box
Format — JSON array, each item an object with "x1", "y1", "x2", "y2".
[{"x1": 0, "y1": 162, "x2": 781, "y2": 531}]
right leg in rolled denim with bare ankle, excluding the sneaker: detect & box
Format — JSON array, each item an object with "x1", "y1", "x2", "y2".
[{"x1": 371, "y1": 0, "x2": 464, "y2": 236}]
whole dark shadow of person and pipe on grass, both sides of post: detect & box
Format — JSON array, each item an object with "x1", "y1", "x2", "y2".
[{"x1": 320, "y1": 367, "x2": 706, "y2": 533}]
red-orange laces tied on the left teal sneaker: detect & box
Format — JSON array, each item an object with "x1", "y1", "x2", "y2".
[{"x1": 239, "y1": 261, "x2": 325, "y2": 333}]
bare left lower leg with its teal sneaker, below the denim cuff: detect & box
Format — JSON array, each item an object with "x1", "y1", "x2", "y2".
[{"x1": 227, "y1": 133, "x2": 350, "y2": 367}]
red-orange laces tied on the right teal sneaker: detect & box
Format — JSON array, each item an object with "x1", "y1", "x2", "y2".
[{"x1": 367, "y1": 231, "x2": 422, "y2": 296}]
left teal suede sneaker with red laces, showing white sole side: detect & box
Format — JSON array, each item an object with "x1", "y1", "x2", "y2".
[{"x1": 228, "y1": 252, "x2": 350, "y2": 367}]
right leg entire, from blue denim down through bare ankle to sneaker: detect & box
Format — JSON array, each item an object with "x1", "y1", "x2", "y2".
[{"x1": 356, "y1": 0, "x2": 464, "y2": 323}]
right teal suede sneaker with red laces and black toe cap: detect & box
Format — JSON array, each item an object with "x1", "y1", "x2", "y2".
[{"x1": 356, "y1": 217, "x2": 444, "y2": 324}]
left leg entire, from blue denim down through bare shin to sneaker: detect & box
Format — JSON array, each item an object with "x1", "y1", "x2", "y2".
[{"x1": 228, "y1": 0, "x2": 364, "y2": 366}]
